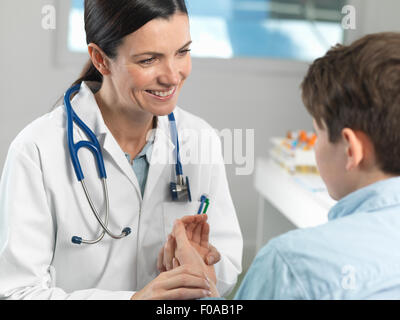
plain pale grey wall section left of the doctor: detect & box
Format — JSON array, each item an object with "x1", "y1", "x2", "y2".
[{"x1": 0, "y1": 0, "x2": 81, "y2": 159}]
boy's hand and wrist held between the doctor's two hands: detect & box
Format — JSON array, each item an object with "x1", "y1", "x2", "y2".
[{"x1": 172, "y1": 220, "x2": 219, "y2": 297}]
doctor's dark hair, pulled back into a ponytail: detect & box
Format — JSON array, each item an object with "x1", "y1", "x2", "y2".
[{"x1": 73, "y1": 0, "x2": 188, "y2": 85}]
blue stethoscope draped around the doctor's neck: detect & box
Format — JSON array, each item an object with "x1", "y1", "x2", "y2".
[{"x1": 64, "y1": 84, "x2": 192, "y2": 244}]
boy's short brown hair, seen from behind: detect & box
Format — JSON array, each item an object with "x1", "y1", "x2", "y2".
[{"x1": 301, "y1": 32, "x2": 400, "y2": 174}]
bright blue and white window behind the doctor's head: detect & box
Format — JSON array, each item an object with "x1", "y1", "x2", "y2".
[{"x1": 68, "y1": 0, "x2": 346, "y2": 61}]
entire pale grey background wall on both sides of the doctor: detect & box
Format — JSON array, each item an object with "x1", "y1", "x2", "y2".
[{"x1": 0, "y1": 0, "x2": 400, "y2": 270}]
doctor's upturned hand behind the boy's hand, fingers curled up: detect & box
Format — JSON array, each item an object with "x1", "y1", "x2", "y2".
[{"x1": 157, "y1": 214, "x2": 221, "y2": 272}]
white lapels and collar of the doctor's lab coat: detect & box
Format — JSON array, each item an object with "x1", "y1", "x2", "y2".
[{"x1": 71, "y1": 82, "x2": 179, "y2": 198}]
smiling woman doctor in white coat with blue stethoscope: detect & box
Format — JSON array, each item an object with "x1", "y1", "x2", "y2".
[{"x1": 0, "y1": 0, "x2": 242, "y2": 299}]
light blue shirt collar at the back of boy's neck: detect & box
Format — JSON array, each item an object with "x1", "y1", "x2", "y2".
[{"x1": 328, "y1": 177, "x2": 400, "y2": 220}]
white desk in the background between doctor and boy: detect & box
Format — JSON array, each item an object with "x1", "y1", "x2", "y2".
[{"x1": 254, "y1": 158, "x2": 336, "y2": 251}]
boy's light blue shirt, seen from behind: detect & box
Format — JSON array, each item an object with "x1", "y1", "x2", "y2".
[{"x1": 235, "y1": 177, "x2": 400, "y2": 299}]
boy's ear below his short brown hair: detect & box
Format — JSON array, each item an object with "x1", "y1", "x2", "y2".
[{"x1": 342, "y1": 128, "x2": 365, "y2": 171}]
